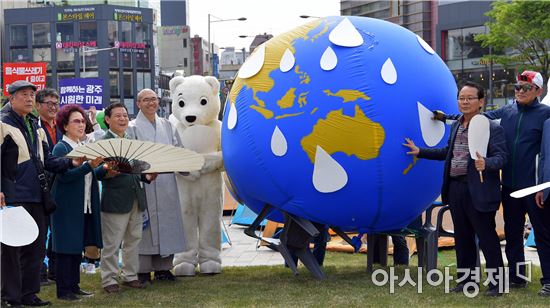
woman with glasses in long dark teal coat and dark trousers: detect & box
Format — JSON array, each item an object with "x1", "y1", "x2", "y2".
[{"x1": 52, "y1": 105, "x2": 105, "y2": 301}]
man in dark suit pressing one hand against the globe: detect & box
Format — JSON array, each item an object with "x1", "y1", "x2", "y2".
[{"x1": 404, "y1": 82, "x2": 507, "y2": 296}]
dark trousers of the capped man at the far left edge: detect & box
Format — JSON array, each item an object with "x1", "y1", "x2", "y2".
[{"x1": 1, "y1": 203, "x2": 46, "y2": 303}]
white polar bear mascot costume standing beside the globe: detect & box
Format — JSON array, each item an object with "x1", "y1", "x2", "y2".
[{"x1": 169, "y1": 76, "x2": 223, "y2": 276}]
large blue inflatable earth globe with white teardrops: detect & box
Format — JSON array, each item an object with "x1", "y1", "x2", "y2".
[{"x1": 222, "y1": 16, "x2": 457, "y2": 232}]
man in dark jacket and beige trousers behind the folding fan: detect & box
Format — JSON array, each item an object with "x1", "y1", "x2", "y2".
[{"x1": 100, "y1": 103, "x2": 156, "y2": 293}]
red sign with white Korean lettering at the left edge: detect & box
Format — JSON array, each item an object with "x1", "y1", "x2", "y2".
[{"x1": 3, "y1": 62, "x2": 46, "y2": 96}]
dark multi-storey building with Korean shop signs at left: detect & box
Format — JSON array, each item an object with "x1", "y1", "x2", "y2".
[{"x1": 2, "y1": 4, "x2": 155, "y2": 115}]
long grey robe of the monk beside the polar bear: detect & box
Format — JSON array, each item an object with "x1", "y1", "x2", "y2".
[{"x1": 128, "y1": 111, "x2": 185, "y2": 260}]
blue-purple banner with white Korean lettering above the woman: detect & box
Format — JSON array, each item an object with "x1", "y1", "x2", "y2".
[{"x1": 59, "y1": 78, "x2": 103, "y2": 110}]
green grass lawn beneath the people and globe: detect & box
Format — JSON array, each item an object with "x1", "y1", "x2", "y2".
[{"x1": 40, "y1": 250, "x2": 550, "y2": 307}]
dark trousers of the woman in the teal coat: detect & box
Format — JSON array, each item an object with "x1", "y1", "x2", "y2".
[{"x1": 55, "y1": 253, "x2": 82, "y2": 297}]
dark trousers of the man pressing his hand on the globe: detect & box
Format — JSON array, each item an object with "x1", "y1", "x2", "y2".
[{"x1": 449, "y1": 180, "x2": 504, "y2": 282}]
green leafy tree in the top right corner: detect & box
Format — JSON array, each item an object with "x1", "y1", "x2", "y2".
[{"x1": 476, "y1": 0, "x2": 550, "y2": 91}]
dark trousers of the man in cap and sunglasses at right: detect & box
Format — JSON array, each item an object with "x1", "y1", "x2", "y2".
[{"x1": 502, "y1": 187, "x2": 550, "y2": 284}]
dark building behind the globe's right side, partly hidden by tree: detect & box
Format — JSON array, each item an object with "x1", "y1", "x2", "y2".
[{"x1": 436, "y1": 1, "x2": 516, "y2": 108}]
